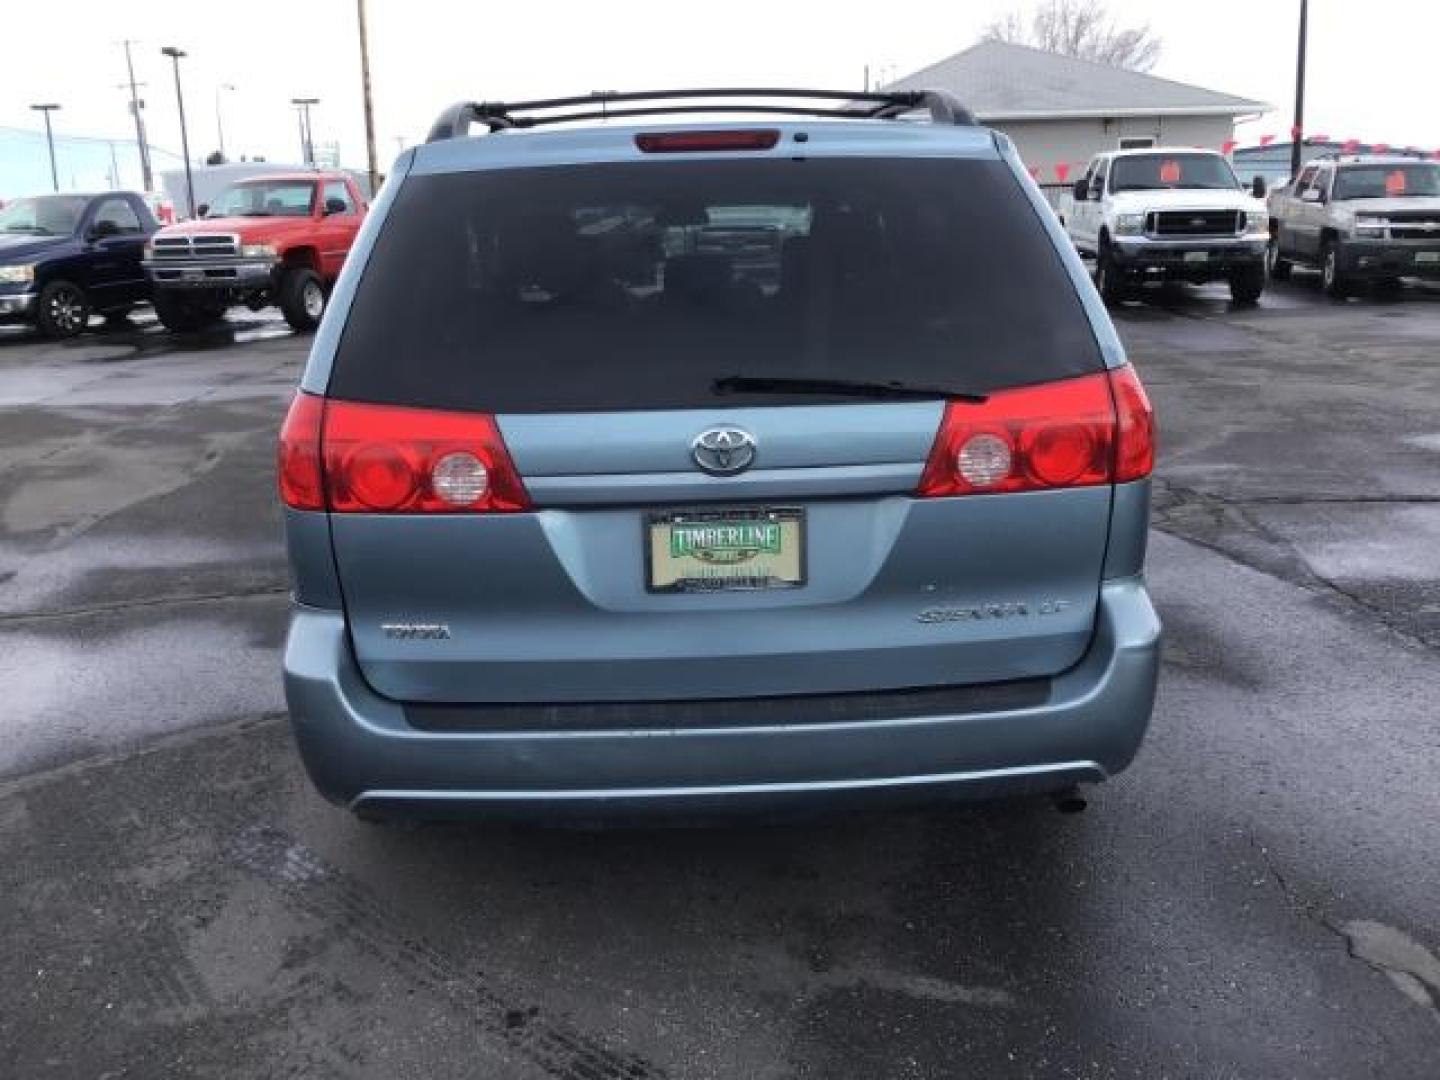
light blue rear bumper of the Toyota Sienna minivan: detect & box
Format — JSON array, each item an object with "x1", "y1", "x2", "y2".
[{"x1": 284, "y1": 577, "x2": 1161, "y2": 818}]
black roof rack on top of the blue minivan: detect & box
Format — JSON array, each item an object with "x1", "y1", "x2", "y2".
[{"x1": 425, "y1": 88, "x2": 975, "y2": 143}]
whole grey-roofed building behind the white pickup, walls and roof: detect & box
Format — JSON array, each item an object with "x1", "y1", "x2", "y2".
[{"x1": 886, "y1": 42, "x2": 1270, "y2": 184}]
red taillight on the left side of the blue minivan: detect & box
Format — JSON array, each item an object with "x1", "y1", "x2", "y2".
[{"x1": 279, "y1": 395, "x2": 530, "y2": 514}]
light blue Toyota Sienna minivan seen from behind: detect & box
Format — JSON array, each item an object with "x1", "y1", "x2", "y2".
[{"x1": 279, "y1": 91, "x2": 1159, "y2": 818}]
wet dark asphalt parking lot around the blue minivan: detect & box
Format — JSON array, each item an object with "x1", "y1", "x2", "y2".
[{"x1": 0, "y1": 275, "x2": 1440, "y2": 1080}]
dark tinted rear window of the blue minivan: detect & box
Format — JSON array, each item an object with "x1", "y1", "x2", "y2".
[{"x1": 330, "y1": 158, "x2": 1102, "y2": 413}]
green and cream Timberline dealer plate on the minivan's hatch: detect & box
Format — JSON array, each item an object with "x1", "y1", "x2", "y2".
[{"x1": 645, "y1": 507, "x2": 805, "y2": 592}]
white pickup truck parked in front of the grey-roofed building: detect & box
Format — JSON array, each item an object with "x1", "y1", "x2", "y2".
[{"x1": 1057, "y1": 148, "x2": 1269, "y2": 304}]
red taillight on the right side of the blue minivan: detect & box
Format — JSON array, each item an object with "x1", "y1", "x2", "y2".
[{"x1": 917, "y1": 367, "x2": 1153, "y2": 497}]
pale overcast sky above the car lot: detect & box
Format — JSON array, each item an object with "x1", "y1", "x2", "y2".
[{"x1": 0, "y1": 0, "x2": 1440, "y2": 168}]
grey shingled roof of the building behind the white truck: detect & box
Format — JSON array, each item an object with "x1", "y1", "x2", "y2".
[{"x1": 886, "y1": 42, "x2": 1270, "y2": 121}]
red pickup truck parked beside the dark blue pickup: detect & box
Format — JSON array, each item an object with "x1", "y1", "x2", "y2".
[{"x1": 145, "y1": 171, "x2": 366, "y2": 331}]
